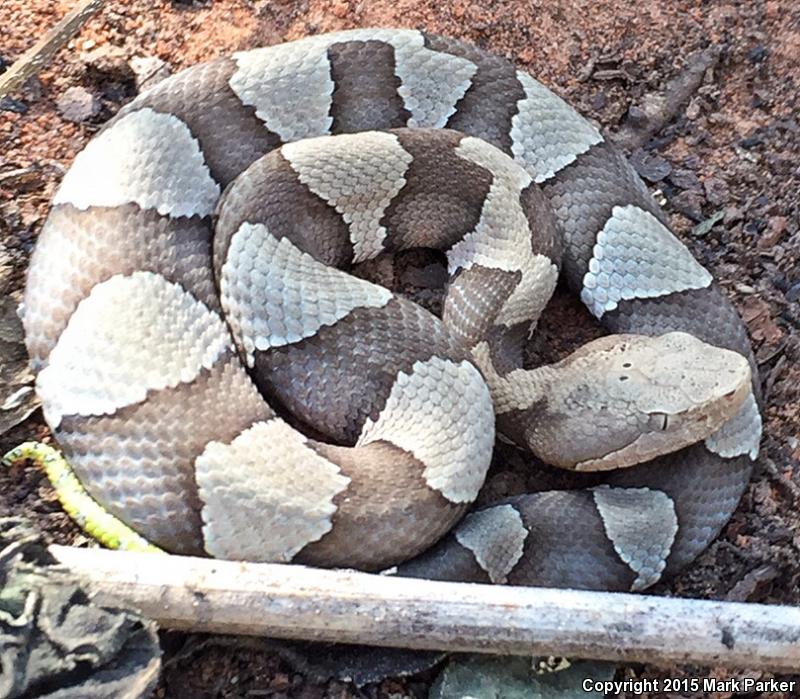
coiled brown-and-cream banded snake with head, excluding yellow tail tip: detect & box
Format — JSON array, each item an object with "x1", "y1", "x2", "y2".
[{"x1": 24, "y1": 29, "x2": 761, "y2": 590}]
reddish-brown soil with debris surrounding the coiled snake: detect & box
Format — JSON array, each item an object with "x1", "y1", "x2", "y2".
[{"x1": 0, "y1": 0, "x2": 800, "y2": 699}]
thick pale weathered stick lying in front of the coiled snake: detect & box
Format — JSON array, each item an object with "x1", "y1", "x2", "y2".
[{"x1": 50, "y1": 546, "x2": 800, "y2": 672}]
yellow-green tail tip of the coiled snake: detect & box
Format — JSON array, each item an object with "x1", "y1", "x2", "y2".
[{"x1": 2, "y1": 442, "x2": 164, "y2": 553}]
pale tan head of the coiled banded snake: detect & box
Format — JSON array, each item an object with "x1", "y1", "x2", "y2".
[{"x1": 525, "y1": 332, "x2": 751, "y2": 471}]
